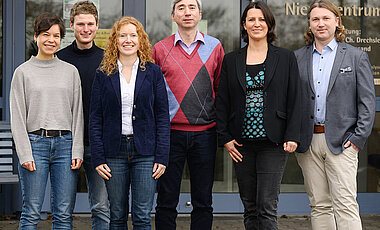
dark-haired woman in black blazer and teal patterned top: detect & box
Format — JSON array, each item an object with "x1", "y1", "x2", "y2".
[{"x1": 216, "y1": 1, "x2": 300, "y2": 229}]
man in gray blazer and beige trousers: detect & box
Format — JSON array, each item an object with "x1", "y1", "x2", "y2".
[{"x1": 295, "y1": 0, "x2": 375, "y2": 230}]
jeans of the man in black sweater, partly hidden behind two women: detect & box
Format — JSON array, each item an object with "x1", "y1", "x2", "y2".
[{"x1": 83, "y1": 146, "x2": 110, "y2": 230}]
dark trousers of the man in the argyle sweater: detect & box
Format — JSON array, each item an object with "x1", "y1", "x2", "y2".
[{"x1": 155, "y1": 128, "x2": 216, "y2": 230}]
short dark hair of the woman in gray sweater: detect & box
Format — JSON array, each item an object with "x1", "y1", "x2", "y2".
[{"x1": 33, "y1": 13, "x2": 66, "y2": 39}]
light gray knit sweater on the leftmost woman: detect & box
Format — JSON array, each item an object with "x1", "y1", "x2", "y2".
[{"x1": 10, "y1": 56, "x2": 83, "y2": 164}]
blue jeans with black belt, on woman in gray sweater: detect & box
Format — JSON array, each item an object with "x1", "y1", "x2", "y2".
[{"x1": 19, "y1": 133, "x2": 79, "y2": 230}]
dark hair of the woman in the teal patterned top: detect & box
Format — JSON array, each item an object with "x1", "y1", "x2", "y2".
[{"x1": 240, "y1": 1, "x2": 277, "y2": 43}]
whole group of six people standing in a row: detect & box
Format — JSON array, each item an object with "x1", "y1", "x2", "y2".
[{"x1": 10, "y1": 0, "x2": 375, "y2": 230}]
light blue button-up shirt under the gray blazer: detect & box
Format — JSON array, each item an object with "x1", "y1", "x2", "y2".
[{"x1": 313, "y1": 38, "x2": 338, "y2": 125}]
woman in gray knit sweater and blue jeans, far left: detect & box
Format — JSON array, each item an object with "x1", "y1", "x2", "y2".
[{"x1": 10, "y1": 13, "x2": 83, "y2": 230}]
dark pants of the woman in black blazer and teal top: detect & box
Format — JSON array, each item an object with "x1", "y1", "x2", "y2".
[{"x1": 234, "y1": 141, "x2": 288, "y2": 230}]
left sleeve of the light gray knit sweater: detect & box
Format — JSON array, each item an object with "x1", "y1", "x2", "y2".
[{"x1": 9, "y1": 67, "x2": 34, "y2": 165}]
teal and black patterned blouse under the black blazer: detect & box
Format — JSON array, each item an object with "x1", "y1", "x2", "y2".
[{"x1": 242, "y1": 63, "x2": 267, "y2": 139}]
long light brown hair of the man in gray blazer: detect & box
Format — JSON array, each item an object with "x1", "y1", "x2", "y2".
[{"x1": 304, "y1": 0, "x2": 347, "y2": 45}]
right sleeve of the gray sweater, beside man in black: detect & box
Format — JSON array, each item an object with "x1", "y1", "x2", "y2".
[{"x1": 71, "y1": 69, "x2": 84, "y2": 160}]
